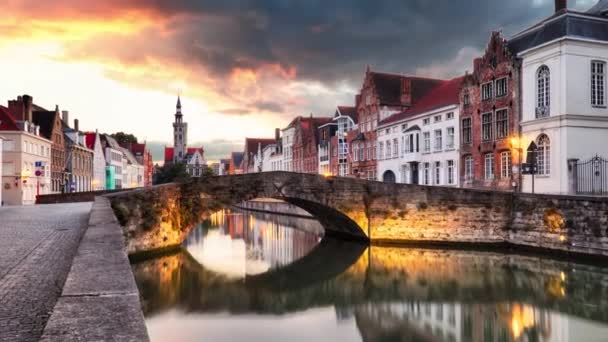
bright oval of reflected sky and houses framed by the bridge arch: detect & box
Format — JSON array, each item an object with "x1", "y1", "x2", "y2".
[{"x1": 184, "y1": 210, "x2": 322, "y2": 278}]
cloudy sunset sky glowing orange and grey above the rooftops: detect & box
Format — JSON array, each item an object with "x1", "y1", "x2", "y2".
[{"x1": 0, "y1": 0, "x2": 596, "y2": 160}]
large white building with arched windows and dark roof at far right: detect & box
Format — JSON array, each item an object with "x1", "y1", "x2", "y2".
[{"x1": 509, "y1": 0, "x2": 608, "y2": 194}]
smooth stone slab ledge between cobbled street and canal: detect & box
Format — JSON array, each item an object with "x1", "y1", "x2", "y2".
[{"x1": 42, "y1": 197, "x2": 149, "y2": 342}]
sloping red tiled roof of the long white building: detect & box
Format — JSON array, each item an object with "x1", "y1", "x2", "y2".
[{"x1": 378, "y1": 76, "x2": 464, "y2": 126}]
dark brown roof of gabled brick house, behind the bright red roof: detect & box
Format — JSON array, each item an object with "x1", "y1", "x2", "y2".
[{"x1": 370, "y1": 71, "x2": 443, "y2": 105}]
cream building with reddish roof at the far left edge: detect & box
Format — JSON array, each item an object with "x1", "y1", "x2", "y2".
[{"x1": 0, "y1": 106, "x2": 51, "y2": 205}]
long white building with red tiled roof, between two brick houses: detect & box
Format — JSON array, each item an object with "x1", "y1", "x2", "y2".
[{"x1": 377, "y1": 77, "x2": 462, "y2": 186}]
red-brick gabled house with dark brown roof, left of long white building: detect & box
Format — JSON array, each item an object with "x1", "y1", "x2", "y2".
[{"x1": 347, "y1": 67, "x2": 441, "y2": 180}]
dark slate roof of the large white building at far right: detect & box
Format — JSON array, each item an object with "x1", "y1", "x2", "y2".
[{"x1": 509, "y1": 9, "x2": 608, "y2": 54}]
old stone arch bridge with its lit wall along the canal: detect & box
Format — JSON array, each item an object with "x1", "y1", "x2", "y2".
[{"x1": 106, "y1": 172, "x2": 608, "y2": 256}]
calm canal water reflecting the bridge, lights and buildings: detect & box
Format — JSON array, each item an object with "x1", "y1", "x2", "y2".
[{"x1": 133, "y1": 210, "x2": 608, "y2": 342}]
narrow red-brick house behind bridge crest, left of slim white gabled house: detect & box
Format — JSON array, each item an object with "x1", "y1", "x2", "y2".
[{"x1": 289, "y1": 115, "x2": 331, "y2": 173}]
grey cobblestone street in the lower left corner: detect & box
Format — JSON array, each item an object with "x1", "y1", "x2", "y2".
[{"x1": 0, "y1": 203, "x2": 91, "y2": 341}]
